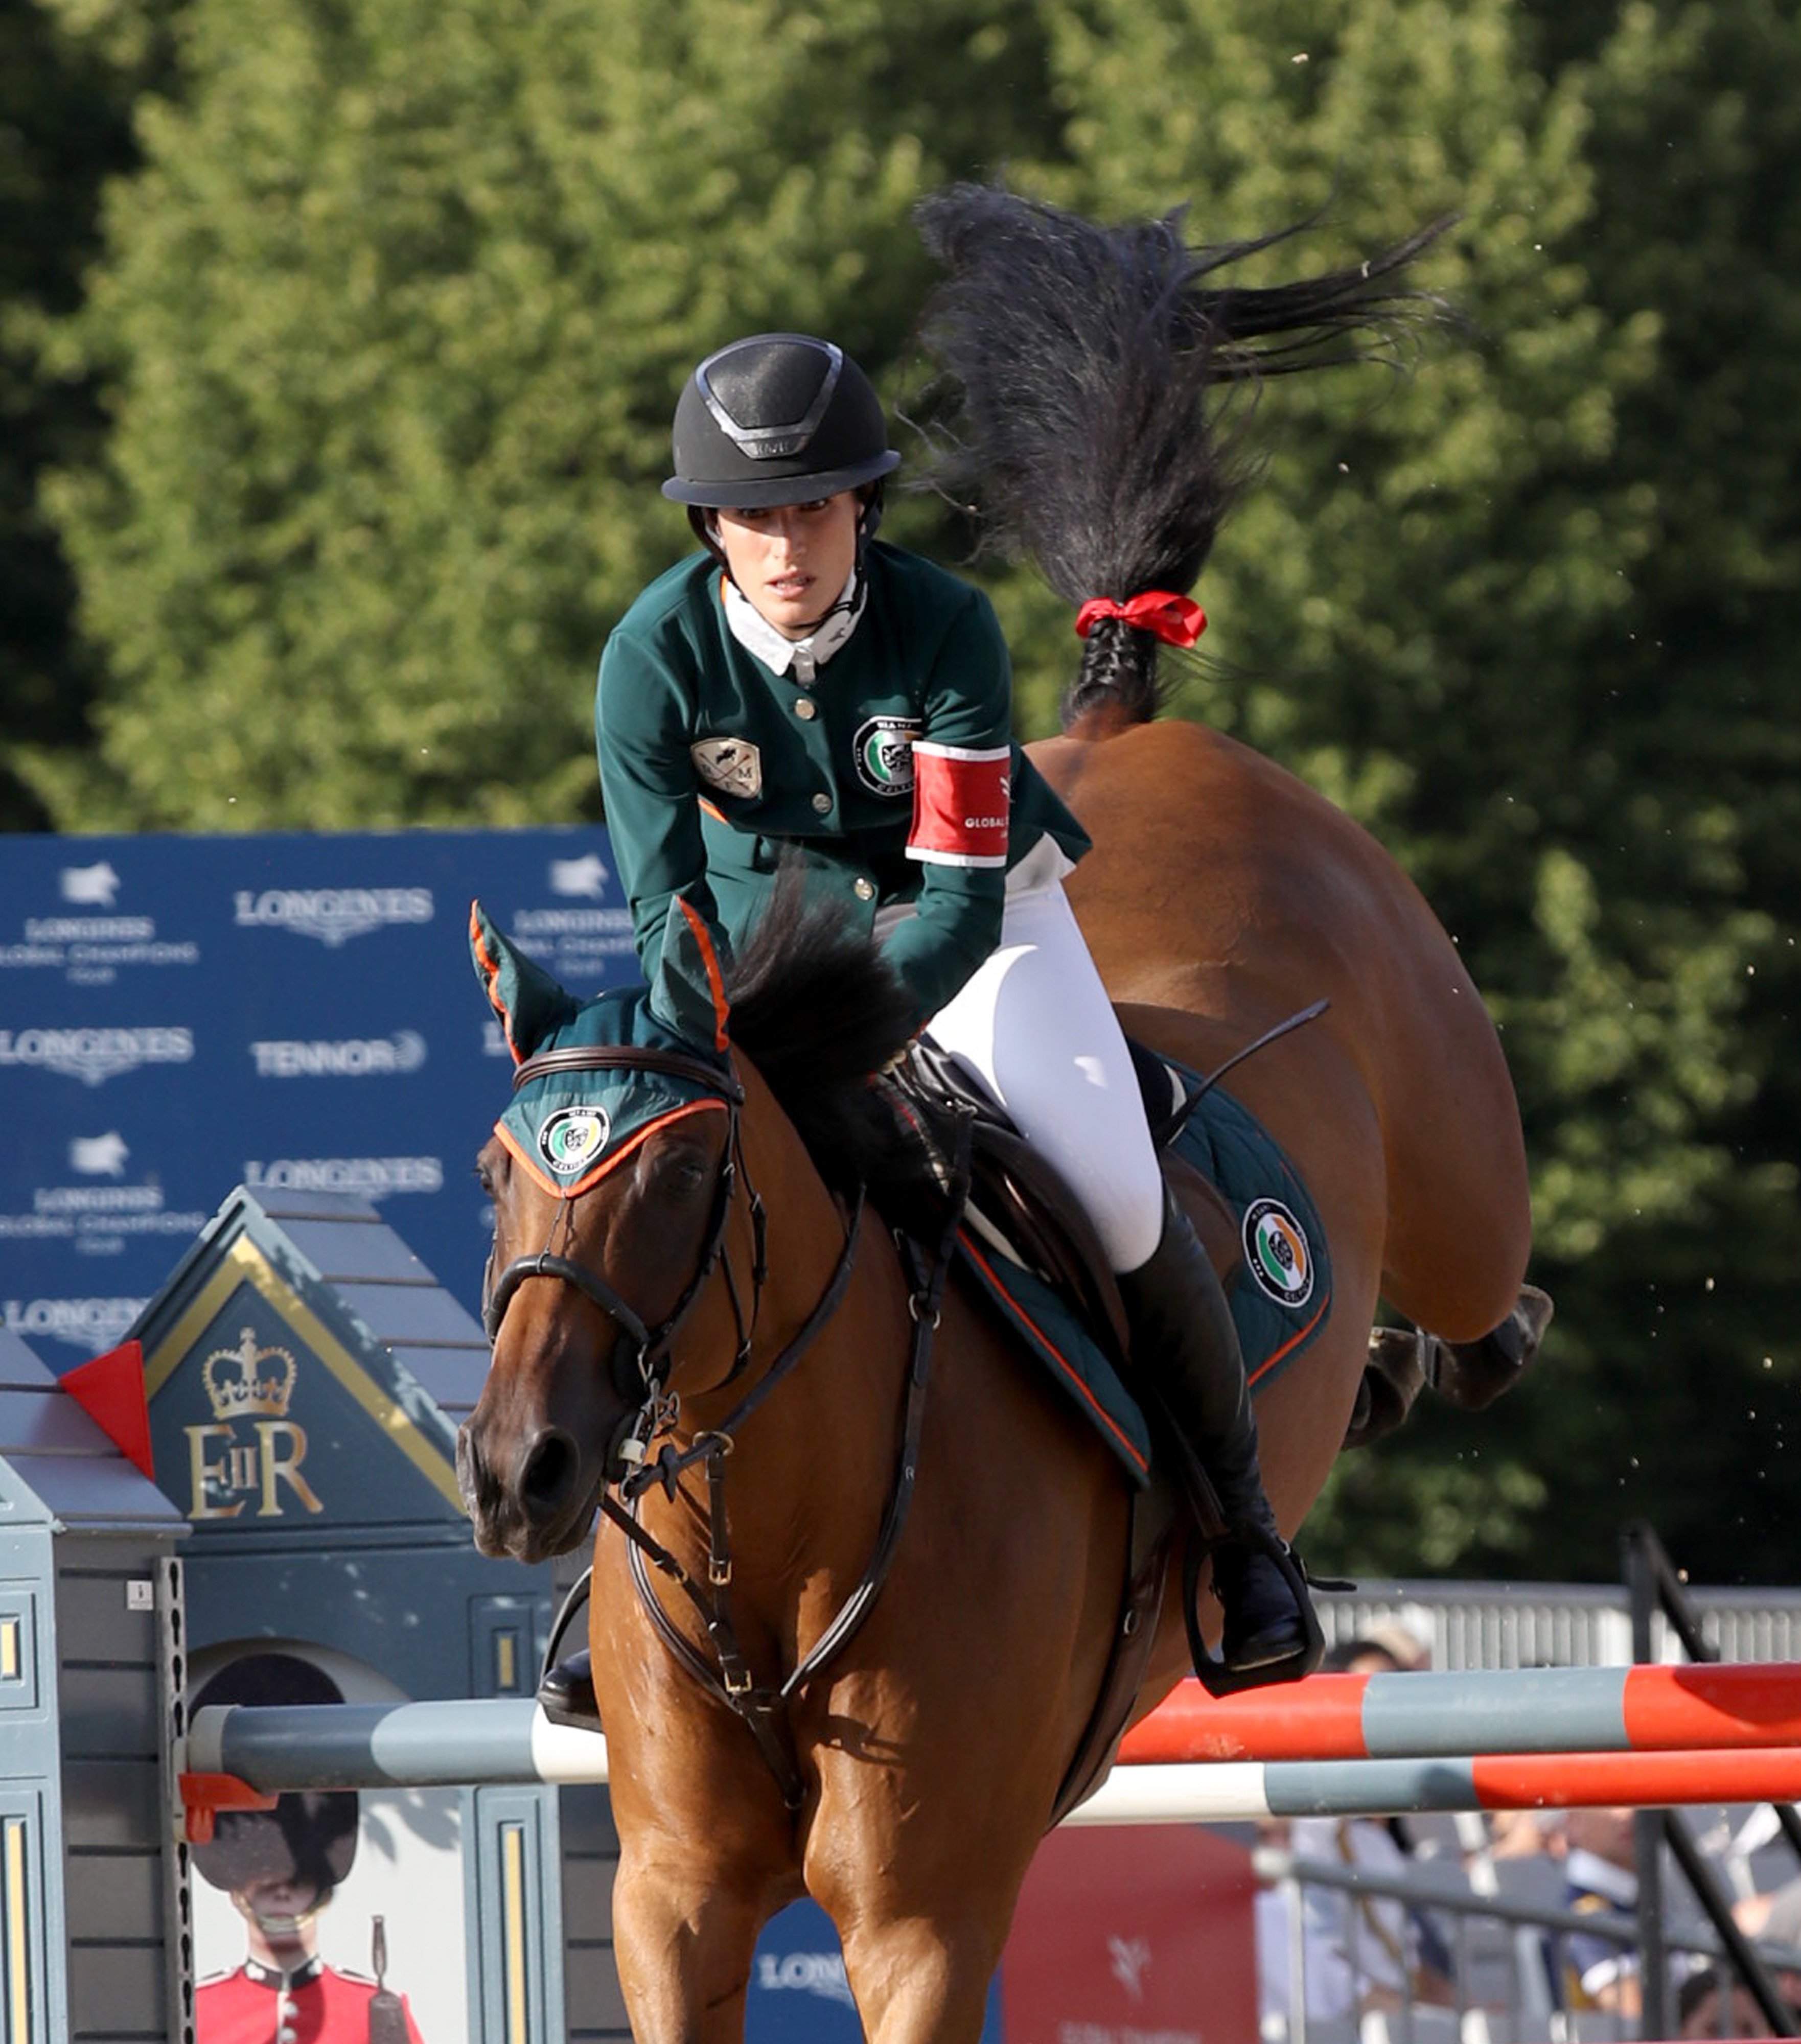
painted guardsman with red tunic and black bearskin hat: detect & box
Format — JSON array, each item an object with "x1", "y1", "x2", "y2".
[{"x1": 190, "y1": 1654, "x2": 421, "y2": 2044}]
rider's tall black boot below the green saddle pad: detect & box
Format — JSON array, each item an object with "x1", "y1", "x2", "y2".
[{"x1": 1118, "y1": 1190, "x2": 1319, "y2": 1674}]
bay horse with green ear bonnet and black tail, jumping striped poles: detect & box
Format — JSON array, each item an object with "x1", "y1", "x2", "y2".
[{"x1": 458, "y1": 190, "x2": 1529, "y2": 2044}]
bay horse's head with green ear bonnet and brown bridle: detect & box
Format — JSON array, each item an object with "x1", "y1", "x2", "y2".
[{"x1": 456, "y1": 905, "x2": 742, "y2": 1562}]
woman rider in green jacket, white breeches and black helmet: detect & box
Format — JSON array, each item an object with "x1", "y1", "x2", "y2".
[{"x1": 595, "y1": 333, "x2": 1308, "y2": 1678}]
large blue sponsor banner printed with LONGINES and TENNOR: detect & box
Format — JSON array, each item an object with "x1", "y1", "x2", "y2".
[{"x1": 0, "y1": 828, "x2": 638, "y2": 1369}]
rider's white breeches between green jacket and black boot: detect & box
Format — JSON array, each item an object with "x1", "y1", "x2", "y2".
[{"x1": 928, "y1": 838, "x2": 1163, "y2": 1271}]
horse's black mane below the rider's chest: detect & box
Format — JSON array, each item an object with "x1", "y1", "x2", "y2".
[{"x1": 726, "y1": 861, "x2": 918, "y2": 1188}]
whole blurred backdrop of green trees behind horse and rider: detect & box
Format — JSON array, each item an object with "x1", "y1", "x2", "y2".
[{"x1": 0, "y1": 0, "x2": 1801, "y2": 1582}]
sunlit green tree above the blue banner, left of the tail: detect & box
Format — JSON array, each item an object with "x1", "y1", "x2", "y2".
[{"x1": 33, "y1": 0, "x2": 1041, "y2": 828}]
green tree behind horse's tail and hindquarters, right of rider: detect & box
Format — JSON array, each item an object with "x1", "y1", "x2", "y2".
[{"x1": 989, "y1": 0, "x2": 1770, "y2": 1576}]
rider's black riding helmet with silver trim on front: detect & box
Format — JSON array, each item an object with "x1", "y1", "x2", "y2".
[{"x1": 662, "y1": 333, "x2": 899, "y2": 511}]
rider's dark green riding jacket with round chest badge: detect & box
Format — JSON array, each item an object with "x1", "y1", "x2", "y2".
[{"x1": 595, "y1": 542, "x2": 1090, "y2": 1038}]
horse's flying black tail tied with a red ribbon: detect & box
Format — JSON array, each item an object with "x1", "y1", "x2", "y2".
[{"x1": 916, "y1": 184, "x2": 1449, "y2": 730}]
